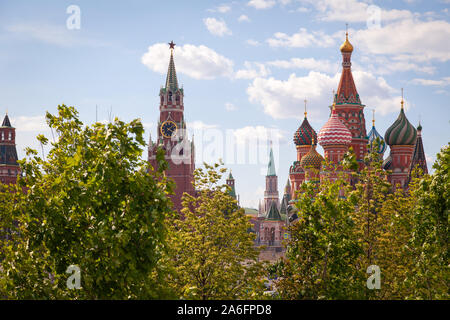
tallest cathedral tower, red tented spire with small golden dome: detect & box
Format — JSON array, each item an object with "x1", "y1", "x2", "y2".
[{"x1": 334, "y1": 32, "x2": 368, "y2": 168}]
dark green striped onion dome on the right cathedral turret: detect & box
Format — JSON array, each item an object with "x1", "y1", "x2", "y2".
[{"x1": 384, "y1": 107, "x2": 417, "y2": 146}]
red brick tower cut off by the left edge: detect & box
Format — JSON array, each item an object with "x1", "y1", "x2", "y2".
[{"x1": 0, "y1": 114, "x2": 20, "y2": 184}]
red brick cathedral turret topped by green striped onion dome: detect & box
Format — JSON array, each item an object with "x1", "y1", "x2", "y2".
[{"x1": 383, "y1": 89, "x2": 417, "y2": 188}]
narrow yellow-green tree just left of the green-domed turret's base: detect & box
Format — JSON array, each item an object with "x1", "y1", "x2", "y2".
[{"x1": 348, "y1": 145, "x2": 402, "y2": 299}]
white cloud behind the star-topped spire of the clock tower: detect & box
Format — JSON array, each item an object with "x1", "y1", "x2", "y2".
[{"x1": 141, "y1": 43, "x2": 233, "y2": 80}]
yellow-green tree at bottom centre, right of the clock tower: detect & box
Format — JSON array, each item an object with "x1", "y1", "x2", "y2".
[{"x1": 167, "y1": 164, "x2": 264, "y2": 300}]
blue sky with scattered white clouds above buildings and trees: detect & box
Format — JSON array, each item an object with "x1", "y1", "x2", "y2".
[{"x1": 0, "y1": 0, "x2": 450, "y2": 207}]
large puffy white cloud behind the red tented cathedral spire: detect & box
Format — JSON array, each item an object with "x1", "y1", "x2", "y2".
[{"x1": 247, "y1": 71, "x2": 400, "y2": 122}]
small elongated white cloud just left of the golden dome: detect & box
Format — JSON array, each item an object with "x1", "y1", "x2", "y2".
[{"x1": 266, "y1": 28, "x2": 335, "y2": 48}]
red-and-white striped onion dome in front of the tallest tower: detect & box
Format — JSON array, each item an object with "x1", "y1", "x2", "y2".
[{"x1": 319, "y1": 106, "x2": 352, "y2": 146}]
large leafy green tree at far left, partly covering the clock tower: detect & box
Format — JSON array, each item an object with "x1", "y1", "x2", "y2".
[{"x1": 0, "y1": 105, "x2": 173, "y2": 299}]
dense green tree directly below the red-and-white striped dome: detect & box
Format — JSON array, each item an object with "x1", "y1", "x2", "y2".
[{"x1": 277, "y1": 178, "x2": 365, "y2": 299}]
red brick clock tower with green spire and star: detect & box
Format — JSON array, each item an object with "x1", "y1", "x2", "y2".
[{"x1": 148, "y1": 41, "x2": 195, "y2": 211}]
